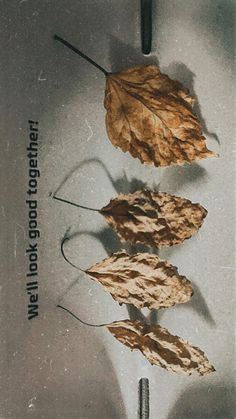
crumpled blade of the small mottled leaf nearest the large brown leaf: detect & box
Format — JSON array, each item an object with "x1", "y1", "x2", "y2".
[{"x1": 100, "y1": 190, "x2": 207, "y2": 247}]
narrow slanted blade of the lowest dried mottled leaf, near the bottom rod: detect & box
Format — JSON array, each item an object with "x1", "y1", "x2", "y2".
[{"x1": 107, "y1": 320, "x2": 215, "y2": 375}]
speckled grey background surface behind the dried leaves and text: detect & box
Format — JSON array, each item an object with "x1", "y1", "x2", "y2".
[{"x1": 0, "y1": 0, "x2": 235, "y2": 419}]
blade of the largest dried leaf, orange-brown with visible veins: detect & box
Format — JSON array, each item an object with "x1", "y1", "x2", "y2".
[{"x1": 104, "y1": 65, "x2": 216, "y2": 166}]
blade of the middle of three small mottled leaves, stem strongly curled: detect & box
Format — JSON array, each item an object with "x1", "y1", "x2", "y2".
[{"x1": 86, "y1": 252, "x2": 193, "y2": 309}]
